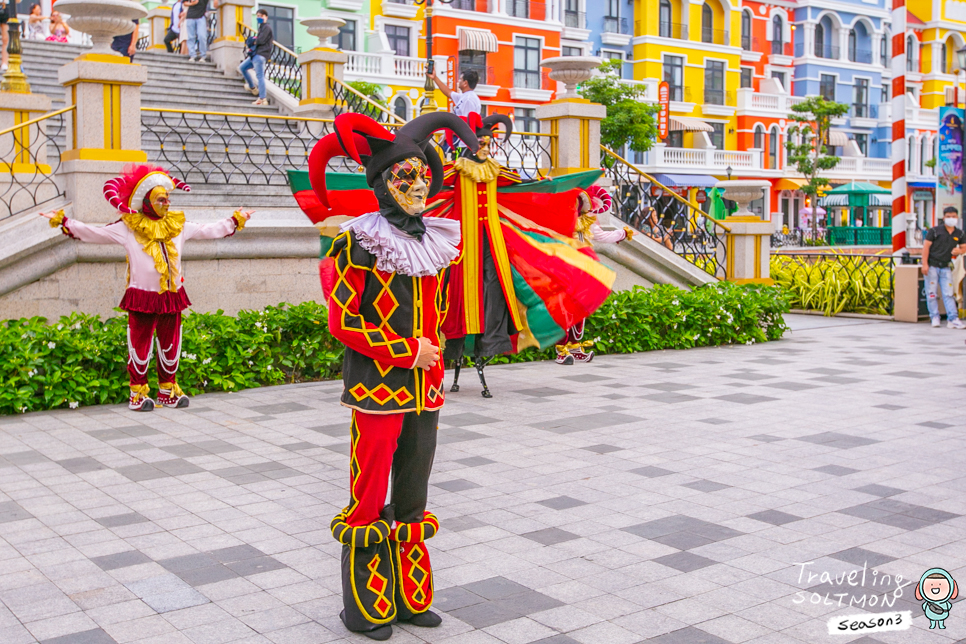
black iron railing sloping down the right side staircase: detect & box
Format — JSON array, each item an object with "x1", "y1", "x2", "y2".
[{"x1": 601, "y1": 146, "x2": 727, "y2": 279}]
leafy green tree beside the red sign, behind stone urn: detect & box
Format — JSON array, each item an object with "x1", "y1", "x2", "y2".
[{"x1": 578, "y1": 60, "x2": 660, "y2": 152}]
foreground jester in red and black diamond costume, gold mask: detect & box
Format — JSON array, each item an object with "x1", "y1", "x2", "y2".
[{"x1": 309, "y1": 112, "x2": 478, "y2": 640}]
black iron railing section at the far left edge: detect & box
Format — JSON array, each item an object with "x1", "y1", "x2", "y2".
[{"x1": 0, "y1": 105, "x2": 74, "y2": 219}]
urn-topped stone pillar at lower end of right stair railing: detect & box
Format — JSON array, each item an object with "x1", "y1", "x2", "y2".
[{"x1": 717, "y1": 179, "x2": 775, "y2": 284}]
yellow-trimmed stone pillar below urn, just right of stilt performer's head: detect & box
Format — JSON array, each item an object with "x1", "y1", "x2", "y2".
[{"x1": 537, "y1": 98, "x2": 607, "y2": 176}]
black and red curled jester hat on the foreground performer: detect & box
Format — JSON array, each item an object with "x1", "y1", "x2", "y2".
[{"x1": 309, "y1": 112, "x2": 480, "y2": 208}]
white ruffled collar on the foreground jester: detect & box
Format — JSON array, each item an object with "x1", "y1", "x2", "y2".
[{"x1": 340, "y1": 212, "x2": 460, "y2": 277}]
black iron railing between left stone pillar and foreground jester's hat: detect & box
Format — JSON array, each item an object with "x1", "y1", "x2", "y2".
[{"x1": 141, "y1": 107, "x2": 356, "y2": 185}]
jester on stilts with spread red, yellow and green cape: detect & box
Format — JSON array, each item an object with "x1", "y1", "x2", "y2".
[{"x1": 432, "y1": 113, "x2": 615, "y2": 398}]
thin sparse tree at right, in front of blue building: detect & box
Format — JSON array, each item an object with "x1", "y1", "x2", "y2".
[{"x1": 785, "y1": 96, "x2": 849, "y2": 233}]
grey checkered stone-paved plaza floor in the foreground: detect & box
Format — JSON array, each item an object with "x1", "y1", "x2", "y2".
[{"x1": 0, "y1": 316, "x2": 966, "y2": 644}]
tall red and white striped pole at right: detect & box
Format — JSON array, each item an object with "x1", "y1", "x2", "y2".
[{"x1": 892, "y1": 0, "x2": 907, "y2": 253}]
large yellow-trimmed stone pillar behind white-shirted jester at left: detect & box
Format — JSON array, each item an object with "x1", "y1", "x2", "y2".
[{"x1": 57, "y1": 58, "x2": 147, "y2": 223}]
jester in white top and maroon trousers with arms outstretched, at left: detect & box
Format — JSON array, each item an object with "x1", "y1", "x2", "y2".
[{"x1": 40, "y1": 165, "x2": 254, "y2": 411}]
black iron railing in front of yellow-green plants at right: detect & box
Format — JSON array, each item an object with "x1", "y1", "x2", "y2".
[{"x1": 771, "y1": 253, "x2": 896, "y2": 315}]
